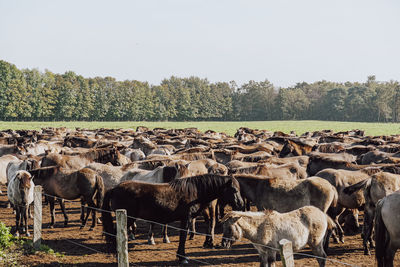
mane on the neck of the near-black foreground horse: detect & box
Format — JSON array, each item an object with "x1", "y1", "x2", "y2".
[{"x1": 169, "y1": 174, "x2": 231, "y2": 199}]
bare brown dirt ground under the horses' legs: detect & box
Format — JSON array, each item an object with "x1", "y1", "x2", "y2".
[{"x1": 0, "y1": 186, "x2": 400, "y2": 266}]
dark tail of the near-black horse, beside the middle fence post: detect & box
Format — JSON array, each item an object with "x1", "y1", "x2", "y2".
[{"x1": 101, "y1": 189, "x2": 116, "y2": 250}]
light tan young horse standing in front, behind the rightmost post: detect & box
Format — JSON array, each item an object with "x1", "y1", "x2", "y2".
[{"x1": 222, "y1": 206, "x2": 335, "y2": 266}]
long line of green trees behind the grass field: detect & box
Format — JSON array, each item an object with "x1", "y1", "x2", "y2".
[{"x1": 0, "y1": 60, "x2": 400, "y2": 122}]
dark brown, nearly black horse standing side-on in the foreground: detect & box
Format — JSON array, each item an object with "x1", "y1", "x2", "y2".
[{"x1": 102, "y1": 174, "x2": 243, "y2": 263}]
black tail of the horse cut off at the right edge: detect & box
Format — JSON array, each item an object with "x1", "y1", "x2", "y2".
[{"x1": 375, "y1": 199, "x2": 389, "y2": 267}]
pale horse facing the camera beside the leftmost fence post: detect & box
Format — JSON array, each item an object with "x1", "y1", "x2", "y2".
[{"x1": 7, "y1": 171, "x2": 35, "y2": 236}]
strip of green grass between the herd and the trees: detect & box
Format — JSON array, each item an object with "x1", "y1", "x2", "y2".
[{"x1": 0, "y1": 121, "x2": 400, "y2": 138}]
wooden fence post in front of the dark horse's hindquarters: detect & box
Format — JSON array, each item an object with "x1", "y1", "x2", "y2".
[{"x1": 115, "y1": 209, "x2": 129, "y2": 267}]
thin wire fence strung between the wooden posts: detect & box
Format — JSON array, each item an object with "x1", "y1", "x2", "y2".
[{"x1": 16, "y1": 192, "x2": 357, "y2": 266}]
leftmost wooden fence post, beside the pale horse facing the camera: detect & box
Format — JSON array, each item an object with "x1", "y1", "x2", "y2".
[{"x1": 33, "y1": 185, "x2": 42, "y2": 250}]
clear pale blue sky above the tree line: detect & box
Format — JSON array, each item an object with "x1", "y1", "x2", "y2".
[{"x1": 0, "y1": 0, "x2": 400, "y2": 87}]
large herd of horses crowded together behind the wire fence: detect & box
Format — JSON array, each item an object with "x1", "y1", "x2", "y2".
[{"x1": 0, "y1": 127, "x2": 400, "y2": 266}]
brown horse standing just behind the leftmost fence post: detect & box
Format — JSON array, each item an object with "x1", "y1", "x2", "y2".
[{"x1": 30, "y1": 166, "x2": 104, "y2": 230}]
